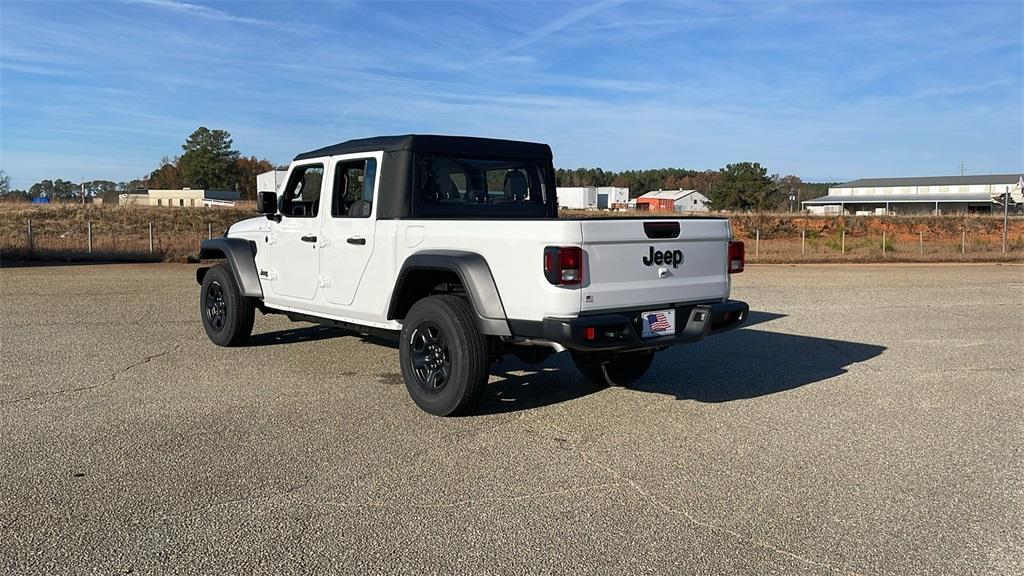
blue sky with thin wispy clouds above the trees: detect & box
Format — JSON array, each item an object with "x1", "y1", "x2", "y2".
[{"x1": 0, "y1": 0, "x2": 1024, "y2": 188}]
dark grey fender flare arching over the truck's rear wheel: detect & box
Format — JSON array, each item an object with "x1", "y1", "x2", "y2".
[{"x1": 387, "y1": 250, "x2": 512, "y2": 336}]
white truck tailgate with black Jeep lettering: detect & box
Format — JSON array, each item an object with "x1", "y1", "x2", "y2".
[{"x1": 582, "y1": 218, "x2": 730, "y2": 312}]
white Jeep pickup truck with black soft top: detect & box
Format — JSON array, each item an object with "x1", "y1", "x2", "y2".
[{"x1": 197, "y1": 135, "x2": 749, "y2": 415}]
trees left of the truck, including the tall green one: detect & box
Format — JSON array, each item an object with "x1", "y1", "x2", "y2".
[{"x1": 0, "y1": 126, "x2": 274, "y2": 203}]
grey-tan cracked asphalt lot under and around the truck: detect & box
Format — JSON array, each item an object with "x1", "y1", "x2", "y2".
[{"x1": 0, "y1": 264, "x2": 1024, "y2": 575}]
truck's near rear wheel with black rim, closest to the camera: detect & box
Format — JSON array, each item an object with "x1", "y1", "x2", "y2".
[{"x1": 398, "y1": 295, "x2": 488, "y2": 416}]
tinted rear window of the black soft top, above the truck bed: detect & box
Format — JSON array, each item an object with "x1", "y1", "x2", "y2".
[{"x1": 415, "y1": 155, "x2": 554, "y2": 216}]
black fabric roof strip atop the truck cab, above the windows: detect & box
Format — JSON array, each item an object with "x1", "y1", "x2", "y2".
[{"x1": 295, "y1": 134, "x2": 551, "y2": 160}]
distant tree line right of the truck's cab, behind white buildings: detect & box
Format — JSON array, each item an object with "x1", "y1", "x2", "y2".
[{"x1": 555, "y1": 162, "x2": 834, "y2": 211}]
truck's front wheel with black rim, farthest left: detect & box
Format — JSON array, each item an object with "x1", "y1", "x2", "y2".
[{"x1": 199, "y1": 262, "x2": 256, "y2": 346}]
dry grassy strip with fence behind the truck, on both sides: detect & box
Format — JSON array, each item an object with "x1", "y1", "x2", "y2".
[{"x1": 0, "y1": 203, "x2": 1024, "y2": 263}]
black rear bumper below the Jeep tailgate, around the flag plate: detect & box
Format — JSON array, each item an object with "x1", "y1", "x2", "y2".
[{"x1": 513, "y1": 300, "x2": 750, "y2": 352}]
